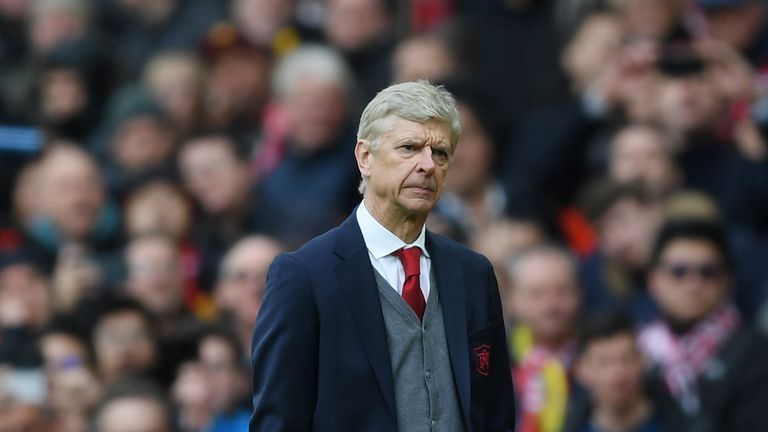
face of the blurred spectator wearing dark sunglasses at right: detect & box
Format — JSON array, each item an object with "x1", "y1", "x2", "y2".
[{"x1": 650, "y1": 239, "x2": 730, "y2": 324}]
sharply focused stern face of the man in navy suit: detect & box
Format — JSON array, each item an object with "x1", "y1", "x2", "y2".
[{"x1": 355, "y1": 117, "x2": 453, "y2": 219}]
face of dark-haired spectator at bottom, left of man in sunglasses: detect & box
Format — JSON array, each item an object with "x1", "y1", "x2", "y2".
[{"x1": 576, "y1": 333, "x2": 643, "y2": 409}]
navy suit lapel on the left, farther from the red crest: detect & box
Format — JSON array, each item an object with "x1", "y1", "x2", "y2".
[{"x1": 334, "y1": 212, "x2": 396, "y2": 419}]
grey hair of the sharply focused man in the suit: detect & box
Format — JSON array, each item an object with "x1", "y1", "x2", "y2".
[{"x1": 357, "y1": 80, "x2": 461, "y2": 193}]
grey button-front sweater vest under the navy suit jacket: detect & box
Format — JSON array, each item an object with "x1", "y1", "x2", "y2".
[{"x1": 374, "y1": 272, "x2": 464, "y2": 432}]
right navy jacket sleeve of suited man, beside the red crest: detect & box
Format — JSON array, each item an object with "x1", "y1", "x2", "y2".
[{"x1": 486, "y1": 262, "x2": 515, "y2": 432}]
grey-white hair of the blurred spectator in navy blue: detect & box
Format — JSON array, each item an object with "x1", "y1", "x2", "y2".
[{"x1": 272, "y1": 44, "x2": 354, "y2": 98}]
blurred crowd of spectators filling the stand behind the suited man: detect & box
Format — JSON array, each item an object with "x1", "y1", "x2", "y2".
[{"x1": 0, "y1": 0, "x2": 768, "y2": 432}]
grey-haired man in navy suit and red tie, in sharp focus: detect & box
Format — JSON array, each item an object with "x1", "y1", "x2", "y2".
[{"x1": 250, "y1": 81, "x2": 514, "y2": 432}]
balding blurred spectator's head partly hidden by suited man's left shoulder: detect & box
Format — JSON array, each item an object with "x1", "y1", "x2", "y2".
[{"x1": 214, "y1": 235, "x2": 283, "y2": 356}]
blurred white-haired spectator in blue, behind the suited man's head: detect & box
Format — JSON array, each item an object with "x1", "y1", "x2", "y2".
[{"x1": 259, "y1": 45, "x2": 357, "y2": 247}]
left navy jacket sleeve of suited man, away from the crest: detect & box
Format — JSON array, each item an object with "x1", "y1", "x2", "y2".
[{"x1": 249, "y1": 254, "x2": 318, "y2": 432}]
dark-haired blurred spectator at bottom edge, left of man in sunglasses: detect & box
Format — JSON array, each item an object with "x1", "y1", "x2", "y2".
[{"x1": 563, "y1": 311, "x2": 664, "y2": 432}]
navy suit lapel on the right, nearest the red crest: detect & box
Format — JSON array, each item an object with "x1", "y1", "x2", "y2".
[{"x1": 427, "y1": 232, "x2": 472, "y2": 431}]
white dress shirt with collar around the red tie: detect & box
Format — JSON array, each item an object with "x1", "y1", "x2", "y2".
[{"x1": 356, "y1": 202, "x2": 431, "y2": 300}]
